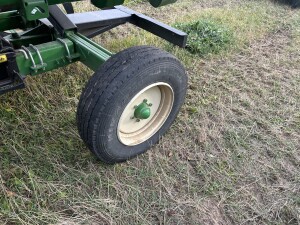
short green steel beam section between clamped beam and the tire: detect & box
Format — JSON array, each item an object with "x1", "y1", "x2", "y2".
[{"x1": 66, "y1": 32, "x2": 113, "y2": 71}]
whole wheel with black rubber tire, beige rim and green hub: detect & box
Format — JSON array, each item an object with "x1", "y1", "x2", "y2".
[{"x1": 77, "y1": 46, "x2": 187, "y2": 164}]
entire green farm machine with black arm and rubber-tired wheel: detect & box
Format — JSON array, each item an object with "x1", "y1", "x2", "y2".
[{"x1": 0, "y1": 0, "x2": 187, "y2": 163}]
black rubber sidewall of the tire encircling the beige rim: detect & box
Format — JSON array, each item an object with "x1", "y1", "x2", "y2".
[{"x1": 93, "y1": 58, "x2": 187, "y2": 161}]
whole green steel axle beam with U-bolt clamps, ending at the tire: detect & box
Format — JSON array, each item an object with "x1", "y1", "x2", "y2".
[{"x1": 16, "y1": 32, "x2": 112, "y2": 76}]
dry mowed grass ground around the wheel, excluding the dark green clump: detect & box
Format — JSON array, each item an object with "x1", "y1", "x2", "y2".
[{"x1": 0, "y1": 0, "x2": 300, "y2": 224}]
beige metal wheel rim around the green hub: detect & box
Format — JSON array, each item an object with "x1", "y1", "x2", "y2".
[{"x1": 117, "y1": 82, "x2": 174, "y2": 146}]
